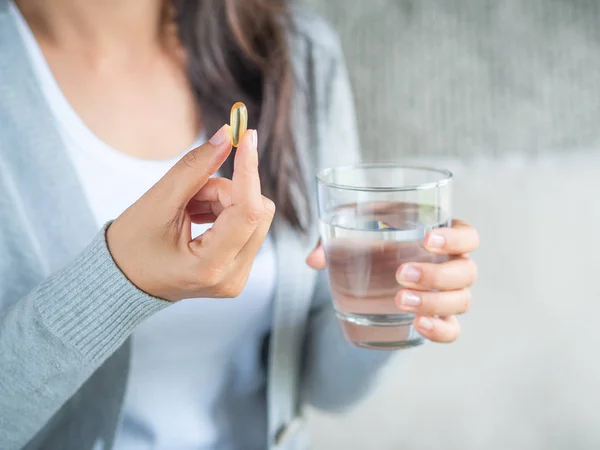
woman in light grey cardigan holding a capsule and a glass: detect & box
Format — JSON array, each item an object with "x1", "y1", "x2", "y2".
[{"x1": 0, "y1": 0, "x2": 477, "y2": 450}]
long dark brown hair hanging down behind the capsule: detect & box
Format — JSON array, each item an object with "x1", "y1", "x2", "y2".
[{"x1": 174, "y1": 0, "x2": 307, "y2": 229}]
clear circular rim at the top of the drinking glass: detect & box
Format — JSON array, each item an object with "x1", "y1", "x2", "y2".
[{"x1": 316, "y1": 163, "x2": 454, "y2": 192}]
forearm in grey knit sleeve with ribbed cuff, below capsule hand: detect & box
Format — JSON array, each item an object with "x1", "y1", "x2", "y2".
[{"x1": 0, "y1": 227, "x2": 166, "y2": 448}]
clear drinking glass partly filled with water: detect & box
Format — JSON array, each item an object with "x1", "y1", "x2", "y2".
[{"x1": 317, "y1": 164, "x2": 452, "y2": 350}]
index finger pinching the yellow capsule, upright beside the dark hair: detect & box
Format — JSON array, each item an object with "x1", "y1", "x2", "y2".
[{"x1": 231, "y1": 130, "x2": 263, "y2": 210}]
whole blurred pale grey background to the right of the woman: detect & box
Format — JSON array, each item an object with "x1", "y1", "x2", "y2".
[{"x1": 307, "y1": 0, "x2": 600, "y2": 450}]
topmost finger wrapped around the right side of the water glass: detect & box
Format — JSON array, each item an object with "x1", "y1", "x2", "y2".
[{"x1": 424, "y1": 220, "x2": 479, "y2": 255}]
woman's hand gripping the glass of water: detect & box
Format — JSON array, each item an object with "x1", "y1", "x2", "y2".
[{"x1": 307, "y1": 220, "x2": 479, "y2": 342}]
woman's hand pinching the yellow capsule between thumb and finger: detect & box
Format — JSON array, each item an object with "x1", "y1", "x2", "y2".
[{"x1": 106, "y1": 125, "x2": 275, "y2": 301}]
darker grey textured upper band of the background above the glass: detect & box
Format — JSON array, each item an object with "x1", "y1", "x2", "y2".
[{"x1": 305, "y1": 0, "x2": 600, "y2": 160}]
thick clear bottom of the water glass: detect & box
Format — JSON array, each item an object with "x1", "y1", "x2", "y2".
[{"x1": 336, "y1": 311, "x2": 425, "y2": 350}]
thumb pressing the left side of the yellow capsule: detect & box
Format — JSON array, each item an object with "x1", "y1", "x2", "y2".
[{"x1": 154, "y1": 125, "x2": 231, "y2": 205}]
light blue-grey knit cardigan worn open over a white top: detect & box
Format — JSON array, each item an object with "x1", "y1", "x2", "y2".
[{"x1": 0, "y1": 0, "x2": 389, "y2": 450}]
